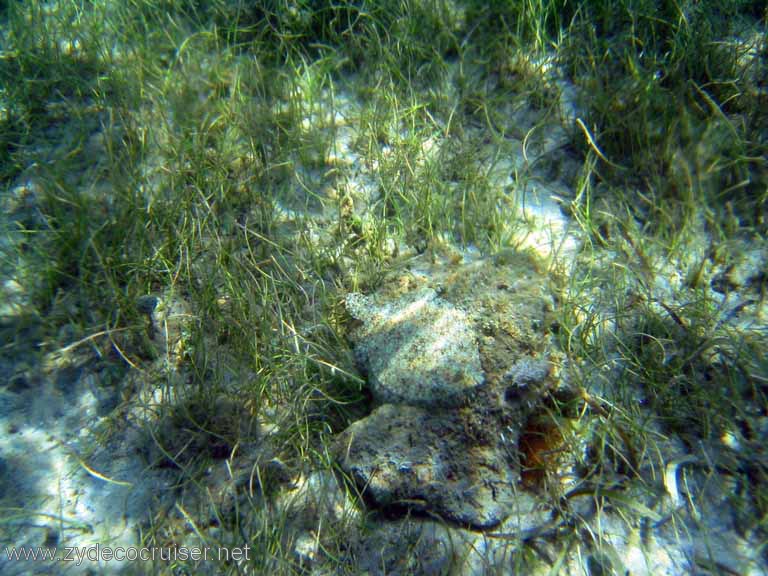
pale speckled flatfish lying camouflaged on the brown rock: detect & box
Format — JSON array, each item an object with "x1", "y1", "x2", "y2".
[{"x1": 346, "y1": 288, "x2": 483, "y2": 406}]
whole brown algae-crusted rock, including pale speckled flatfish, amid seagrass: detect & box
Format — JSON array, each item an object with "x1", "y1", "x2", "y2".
[{"x1": 335, "y1": 255, "x2": 555, "y2": 529}]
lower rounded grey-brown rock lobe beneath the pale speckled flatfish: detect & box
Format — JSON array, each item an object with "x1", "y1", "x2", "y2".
[{"x1": 336, "y1": 404, "x2": 519, "y2": 528}]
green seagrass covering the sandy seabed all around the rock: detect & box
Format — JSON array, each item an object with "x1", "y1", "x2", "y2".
[{"x1": 0, "y1": 0, "x2": 768, "y2": 574}]
